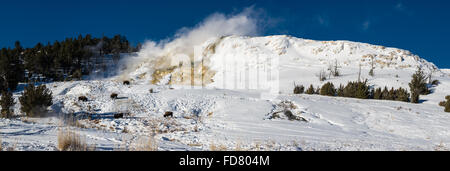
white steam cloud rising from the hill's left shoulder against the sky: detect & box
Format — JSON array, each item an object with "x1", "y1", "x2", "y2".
[{"x1": 122, "y1": 7, "x2": 261, "y2": 79}]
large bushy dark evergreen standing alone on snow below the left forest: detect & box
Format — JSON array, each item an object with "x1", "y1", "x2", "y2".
[{"x1": 19, "y1": 84, "x2": 53, "y2": 117}]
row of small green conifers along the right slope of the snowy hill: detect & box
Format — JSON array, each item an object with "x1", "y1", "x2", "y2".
[{"x1": 294, "y1": 68, "x2": 434, "y2": 103}]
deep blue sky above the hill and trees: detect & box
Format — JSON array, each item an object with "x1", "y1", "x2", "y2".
[{"x1": 0, "y1": 0, "x2": 450, "y2": 68}]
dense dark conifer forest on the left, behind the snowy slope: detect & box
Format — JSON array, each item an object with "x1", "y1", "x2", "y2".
[{"x1": 0, "y1": 34, "x2": 140, "y2": 91}]
